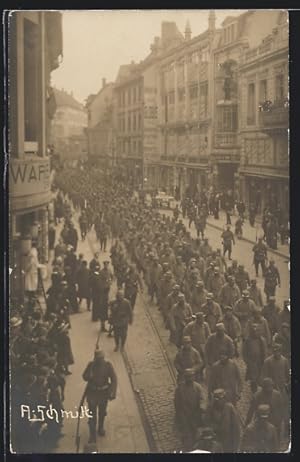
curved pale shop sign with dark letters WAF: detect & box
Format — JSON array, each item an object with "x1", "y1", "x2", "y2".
[{"x1": 9, "y1": 158, "x2": 50, "y2": 197}]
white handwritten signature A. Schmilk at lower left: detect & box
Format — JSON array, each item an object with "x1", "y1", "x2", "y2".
[{"x1": 20, "y1": 404, "x2": 93, "y2": 423}]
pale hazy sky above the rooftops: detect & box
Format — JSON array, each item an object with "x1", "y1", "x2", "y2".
[{"x1": 51, "y1": 10, "x2": 242, "y2": 103}]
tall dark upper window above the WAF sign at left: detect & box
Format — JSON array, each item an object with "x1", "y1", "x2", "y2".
[{"x1": 24, "y1": 19, "x2": 39, "y2": 142}]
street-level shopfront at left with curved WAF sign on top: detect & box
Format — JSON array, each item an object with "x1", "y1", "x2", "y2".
[{"x1": 9, "y1": 156, "x2": 52, "y2": 304}]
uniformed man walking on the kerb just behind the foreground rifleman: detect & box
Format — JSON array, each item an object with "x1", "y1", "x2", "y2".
[{"x1": 110, "y1": 289, "x2": 132, "y2": 351}]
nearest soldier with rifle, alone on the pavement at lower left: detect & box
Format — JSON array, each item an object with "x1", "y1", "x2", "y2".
[{"x1": 82, "y1": 350, "x2": 117, "y2": 443}]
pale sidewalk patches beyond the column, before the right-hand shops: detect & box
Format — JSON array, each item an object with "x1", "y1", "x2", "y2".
[{"x1": 207, "y1": 211, "x2": 290, "y2": 258}]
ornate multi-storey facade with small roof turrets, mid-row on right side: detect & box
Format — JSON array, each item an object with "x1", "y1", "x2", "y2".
[{"x1": 155, "y1": 14, "x2": 215, "y2": 198}]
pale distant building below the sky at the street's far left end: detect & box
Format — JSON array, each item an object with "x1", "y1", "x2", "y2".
[{"x1": 51, "y1": 88, "x2": 87, "y2": 162}]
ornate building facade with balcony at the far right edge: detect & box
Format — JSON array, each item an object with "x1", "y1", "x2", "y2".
[{"x1": 239, "y1": 11, "x2": 289, "y2": 218}]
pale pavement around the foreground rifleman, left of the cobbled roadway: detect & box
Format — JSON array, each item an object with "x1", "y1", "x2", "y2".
[{"x1": 55, "y1": 218, "x2": 149, "y2": 453}]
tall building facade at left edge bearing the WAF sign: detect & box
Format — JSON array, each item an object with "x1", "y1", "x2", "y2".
[{"x1": 9, "y1": 11, "x2": 62, "y2": 278}]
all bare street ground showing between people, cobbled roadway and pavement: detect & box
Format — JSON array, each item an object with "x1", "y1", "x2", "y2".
[{"x1": 50, "y1": 205, "x2": 289, "y2": 453}]
